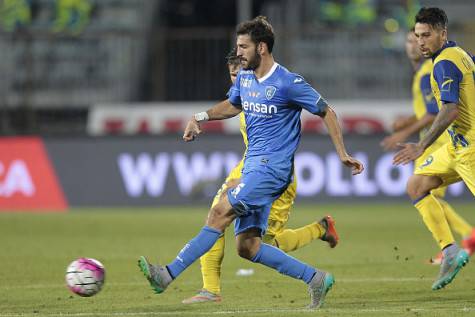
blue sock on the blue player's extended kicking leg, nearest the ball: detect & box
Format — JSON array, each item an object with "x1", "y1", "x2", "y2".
[{"x1": 167, "y1": 226, "x2": 222, "y2": 279}]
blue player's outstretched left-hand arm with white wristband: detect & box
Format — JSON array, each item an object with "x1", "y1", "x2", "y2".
[{"x1": 183, "y1": 99, "x2": 241, "y2": 142}]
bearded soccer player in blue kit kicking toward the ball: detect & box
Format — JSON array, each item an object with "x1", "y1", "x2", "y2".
[{"x1": 139, "y1": 17, "x2": 363, "y2": 308}]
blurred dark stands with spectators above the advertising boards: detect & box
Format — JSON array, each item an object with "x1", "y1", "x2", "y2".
[{"x1": 0, "y1": 0, "x2": 475, "y2": 135}]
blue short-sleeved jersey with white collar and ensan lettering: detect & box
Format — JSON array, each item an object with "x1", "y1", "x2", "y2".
[{"x1": 229, "y1": 63, "x2": 327, "y2": 173}]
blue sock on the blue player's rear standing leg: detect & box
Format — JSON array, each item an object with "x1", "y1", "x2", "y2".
[{"x1": 251, "y1": 243, "x2": 316, "y2": 284}]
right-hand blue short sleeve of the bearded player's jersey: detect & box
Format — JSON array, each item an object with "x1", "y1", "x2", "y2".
[{"x1": 288, "y1": 75, "x2": 328, "y2": 115}]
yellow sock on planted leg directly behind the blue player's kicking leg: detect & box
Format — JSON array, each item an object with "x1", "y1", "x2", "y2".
[{"x1": 200, "y1": 235, "x2": 224, "y2": 294}]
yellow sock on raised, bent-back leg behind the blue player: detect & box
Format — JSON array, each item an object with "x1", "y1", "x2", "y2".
[{"x1": 274, "y1": 222, "x2": 325, "y2": 252}]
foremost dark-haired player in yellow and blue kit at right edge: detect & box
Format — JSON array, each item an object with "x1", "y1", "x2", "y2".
[{"x1": 394, "y1": 8, "x2": 475, "y2": 290}]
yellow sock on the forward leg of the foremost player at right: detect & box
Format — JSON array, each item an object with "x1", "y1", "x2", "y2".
[{"x1": 414, "y1": 194, "x2": 455, "y2": 249}]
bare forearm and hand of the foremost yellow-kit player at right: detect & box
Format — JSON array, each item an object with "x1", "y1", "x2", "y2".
[{"x1": 393, "y1": 103, "x2": 459, "y2": 165}]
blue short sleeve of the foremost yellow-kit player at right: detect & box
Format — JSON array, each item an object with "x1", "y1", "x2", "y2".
[{"x1": 434, "y1": 60, "x2": 463, "y2": 103}]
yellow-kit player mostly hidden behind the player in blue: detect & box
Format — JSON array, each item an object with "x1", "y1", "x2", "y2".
[{"x1": 182, "y1": 49, "x2": 338, "y2": 304}]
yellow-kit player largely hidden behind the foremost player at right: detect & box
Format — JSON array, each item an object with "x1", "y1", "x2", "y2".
[{"x1": 381, "y1": 30, "x2": 475, "y2": 264}]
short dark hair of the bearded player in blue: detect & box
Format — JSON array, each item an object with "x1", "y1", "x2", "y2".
[{"x1": 236, "y1": 15, "x2": 274, "y2": 53}]
